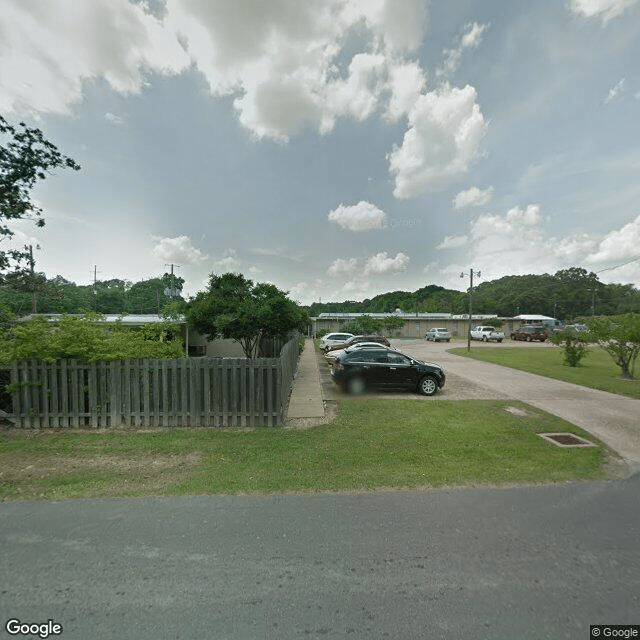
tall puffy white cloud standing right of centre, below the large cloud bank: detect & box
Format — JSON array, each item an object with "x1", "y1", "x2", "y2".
[{"x1": 389, "y1": 85, "x2": 487, "y2": 198}]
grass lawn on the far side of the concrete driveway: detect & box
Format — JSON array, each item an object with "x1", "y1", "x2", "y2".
[{"x1": 450, "y1": 346, "x2": 640, "y2": 398}]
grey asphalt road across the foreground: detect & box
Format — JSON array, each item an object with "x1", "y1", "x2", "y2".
[{"x1": 0, "y1": 475, "x2": 640, "y2": 640}]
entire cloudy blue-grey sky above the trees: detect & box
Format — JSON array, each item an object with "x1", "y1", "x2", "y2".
[{"x1": 0, "y1": 0, "x2": 640, "y2": 304}]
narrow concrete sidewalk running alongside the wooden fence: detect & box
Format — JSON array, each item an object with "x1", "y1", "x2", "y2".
[{"x1": 285, "y1": 338, "x2": 325, "y2": 426}]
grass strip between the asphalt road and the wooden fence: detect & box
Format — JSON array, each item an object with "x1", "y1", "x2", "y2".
[{"x1": 0, "y1": 397, "x2": 609, "y2": 500}]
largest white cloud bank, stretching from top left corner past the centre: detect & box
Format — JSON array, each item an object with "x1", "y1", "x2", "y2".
[{"x1": 0, "y1": 0, "x2": 436, "y2": 141}]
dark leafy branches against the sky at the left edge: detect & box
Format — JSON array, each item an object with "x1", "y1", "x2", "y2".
[{"x1": 0, "y1": 116, "x2": 80, "y2": 272}]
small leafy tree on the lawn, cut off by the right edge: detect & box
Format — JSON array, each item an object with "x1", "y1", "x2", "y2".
[{"x1": 585, "y1": 313, "x2": 640, "y2": 380}]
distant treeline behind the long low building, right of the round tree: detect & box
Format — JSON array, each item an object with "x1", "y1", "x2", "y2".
[{"x1": 307, "y1": 267, "x2": 640, "y2": 320}]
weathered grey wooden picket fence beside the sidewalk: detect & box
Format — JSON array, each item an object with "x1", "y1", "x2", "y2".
[{"x1": 8, "y1": 336, "x2": 299, "y2": 428}]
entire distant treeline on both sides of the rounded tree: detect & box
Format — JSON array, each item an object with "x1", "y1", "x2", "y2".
[{"x1": 5, "y1": 267, "x2": 640, "y2": 320}]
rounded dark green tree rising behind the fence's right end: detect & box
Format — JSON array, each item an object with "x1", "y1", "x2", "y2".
[{"x1": 187, "y1": 273, "x2": 309, "y2": 358}]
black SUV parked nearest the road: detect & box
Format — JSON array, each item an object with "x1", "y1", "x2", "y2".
[{"x1": 331, "y1": 348, "x2": 445, "y2": 396}]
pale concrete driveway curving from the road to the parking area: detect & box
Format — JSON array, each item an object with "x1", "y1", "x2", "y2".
[{"x1": 320, "y1": 340, "x2": 640, "y2": 466}]
